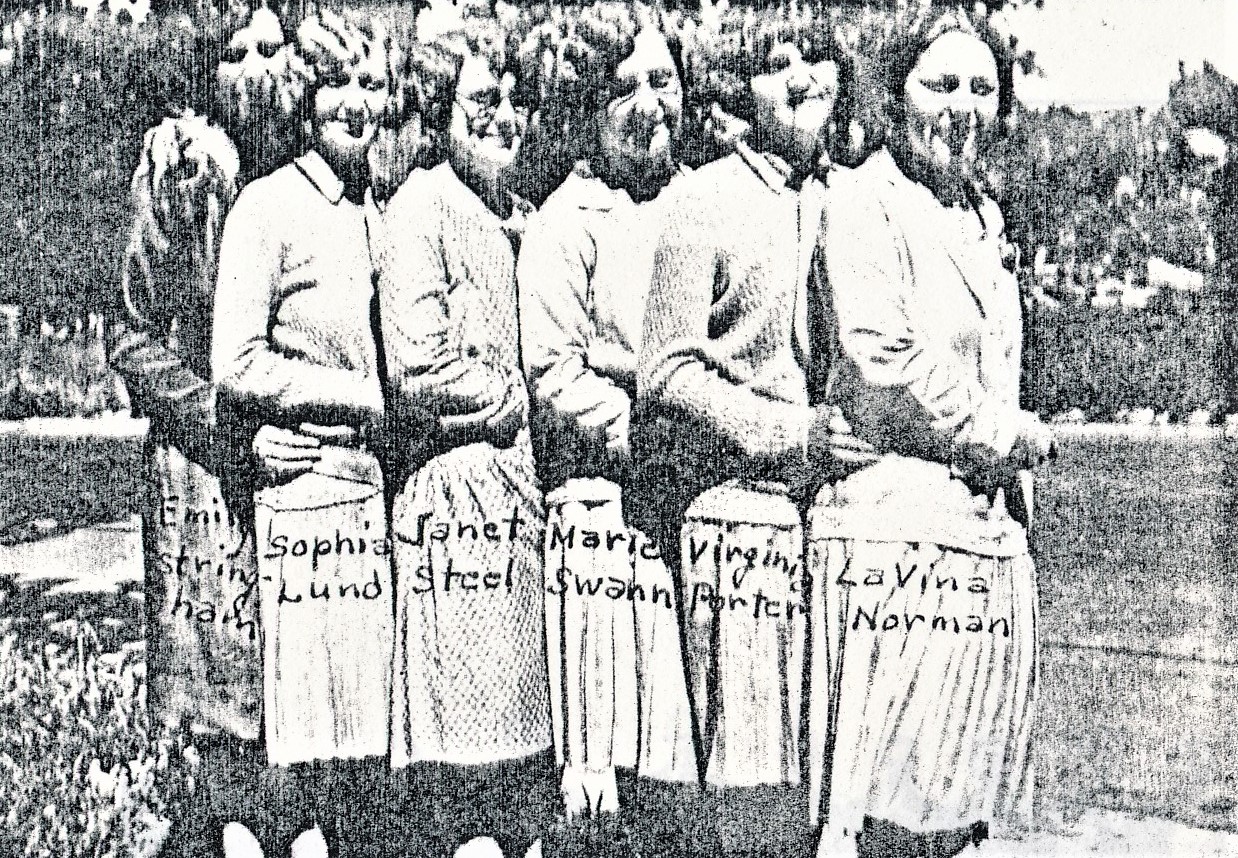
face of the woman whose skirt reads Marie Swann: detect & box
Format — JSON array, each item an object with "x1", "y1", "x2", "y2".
[{"x1": 598, "y1": 27, "x2": 683, "y2": 189}]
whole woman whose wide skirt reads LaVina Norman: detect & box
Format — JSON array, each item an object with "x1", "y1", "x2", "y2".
[{"x1": 810, "y1": 9, "x2": 1052, "y2": 858}]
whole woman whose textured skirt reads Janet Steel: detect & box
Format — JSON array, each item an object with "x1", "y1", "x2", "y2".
[{"x1": 378, "y1": 15, "x2": 553, "y2": 856}]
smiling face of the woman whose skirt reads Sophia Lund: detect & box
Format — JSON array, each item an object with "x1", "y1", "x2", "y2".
[{"x1": 313, "y1": 51, "x2": 387, "y2": 172}]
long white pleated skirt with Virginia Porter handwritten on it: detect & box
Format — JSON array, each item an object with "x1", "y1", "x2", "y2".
[{"x1": 681, "y1": 484, "x2": 807, "y2": 787}]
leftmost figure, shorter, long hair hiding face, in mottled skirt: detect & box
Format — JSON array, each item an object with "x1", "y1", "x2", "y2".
[{"x1": 109, "y1": 116, "x2": 284, "y2": 856}]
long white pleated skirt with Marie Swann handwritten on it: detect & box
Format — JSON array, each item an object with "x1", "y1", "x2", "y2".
[{"x1": 546, "y1": 479, "x2": 697, "y2": 782}]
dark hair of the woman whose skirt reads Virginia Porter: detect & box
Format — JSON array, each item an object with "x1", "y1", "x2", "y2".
[{"x1": 685, "y1": 5, "x2": 857, "y2": 163}]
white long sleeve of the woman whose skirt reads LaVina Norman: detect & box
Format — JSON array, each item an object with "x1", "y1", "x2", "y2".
[{"x1": 822, "y1": 185, "x2": 1016, "y2": 458}]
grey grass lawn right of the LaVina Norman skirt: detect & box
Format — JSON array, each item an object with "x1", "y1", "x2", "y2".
[{"x1": 1034, "y1": 432, "x2": 1238, "y2": 831}]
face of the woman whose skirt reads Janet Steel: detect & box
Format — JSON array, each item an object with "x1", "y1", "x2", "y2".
[{"x1": 449, "y1": 54, "x2": 526, "y2": 181}]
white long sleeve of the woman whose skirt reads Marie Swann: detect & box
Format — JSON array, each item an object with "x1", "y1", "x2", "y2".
[{"x1": 516, "y1": 208, "x2": 635, "y2": 477}]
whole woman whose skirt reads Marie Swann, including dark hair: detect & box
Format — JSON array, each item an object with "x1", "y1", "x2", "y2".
[{"x1": 516, "y1": 2, "x2": 696, "y2": 854}]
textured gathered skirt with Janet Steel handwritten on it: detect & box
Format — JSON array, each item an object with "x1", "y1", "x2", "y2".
[{"x1": 391, "y1": 437, "x2": 551, "y2": 768}]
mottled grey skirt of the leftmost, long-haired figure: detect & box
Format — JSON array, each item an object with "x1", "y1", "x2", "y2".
[{"x1": 142, "y1": 444, "x2": 262, "y2": 739}]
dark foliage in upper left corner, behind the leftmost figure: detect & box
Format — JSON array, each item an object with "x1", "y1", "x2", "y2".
[{"x1": 0, "y1": 12, "x2": 220, "y2": 308}]
